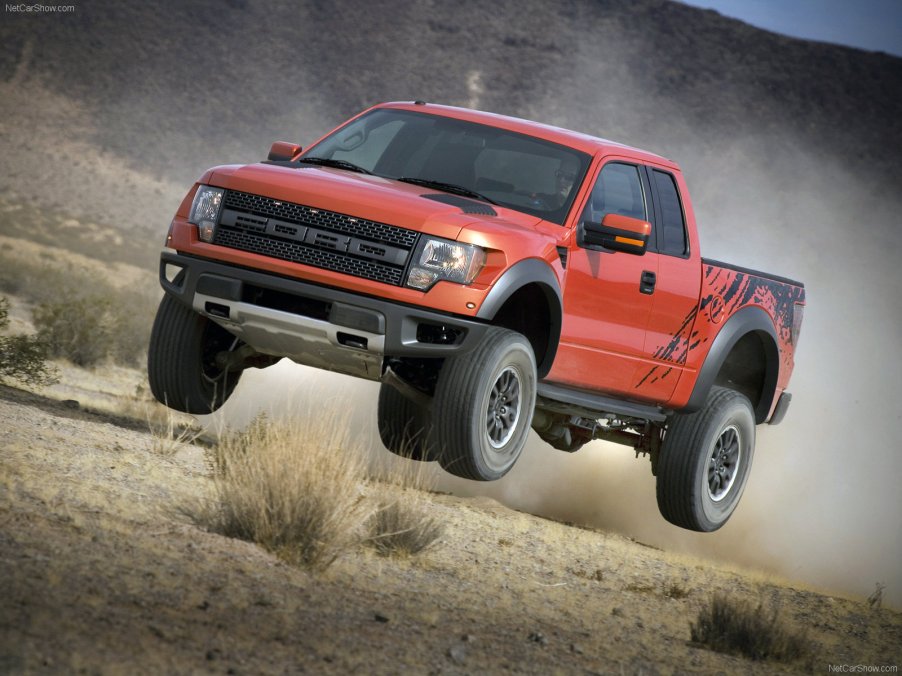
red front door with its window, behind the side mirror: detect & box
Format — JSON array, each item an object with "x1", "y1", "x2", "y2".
[{"x1": 548, "y1": 161, "x2": 658, "y2": 399}]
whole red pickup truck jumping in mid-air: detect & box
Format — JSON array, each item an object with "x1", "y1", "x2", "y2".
[{"x1": 148, "y1": 101, "x2": 805, "y2": 531}]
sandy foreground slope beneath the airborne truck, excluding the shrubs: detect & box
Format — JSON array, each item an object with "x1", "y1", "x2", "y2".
[{"x1": 0, "y1": 369, "x2": 902, "y2": 674}]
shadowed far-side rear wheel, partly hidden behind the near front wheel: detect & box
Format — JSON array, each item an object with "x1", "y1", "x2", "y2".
[{"x1": 376, "y1": 384, "x2": 438, "y2": 461}]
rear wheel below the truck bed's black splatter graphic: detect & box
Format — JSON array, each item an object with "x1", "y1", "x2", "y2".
[{"x1": 657, "y1": 387, "x2": 755, "y2": 532}]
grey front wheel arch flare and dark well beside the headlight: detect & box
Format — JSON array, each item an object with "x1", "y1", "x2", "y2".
[{"x1": 476, "y1": 258, "x2": 563, "y2": 378}]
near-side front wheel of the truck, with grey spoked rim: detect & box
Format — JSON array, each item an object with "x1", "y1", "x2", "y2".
[{"x1": 432, "y1": 327, "x2": 536, "y2": 481}]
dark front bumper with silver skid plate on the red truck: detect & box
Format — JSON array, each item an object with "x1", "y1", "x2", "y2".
[{"x1": 160, "y1": 251, "x2": 488, "y2": 380}]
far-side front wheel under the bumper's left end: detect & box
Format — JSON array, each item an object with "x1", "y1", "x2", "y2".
[{"x1": 147, "y1": 294, "x2": 241, "y2": 414}]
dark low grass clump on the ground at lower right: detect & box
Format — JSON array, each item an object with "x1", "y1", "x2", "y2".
[{"x1": 690, "y1": 594, "x2": 810, "y2": 662}]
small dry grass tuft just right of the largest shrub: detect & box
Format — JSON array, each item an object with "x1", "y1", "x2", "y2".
[{"x1": 367, "y1": 489, "x2": 444, "y2": 556}]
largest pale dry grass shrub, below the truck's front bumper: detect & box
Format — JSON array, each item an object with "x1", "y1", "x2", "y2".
[{"x1": 194, "y1": 418, "x2": 369, "y2": 570}]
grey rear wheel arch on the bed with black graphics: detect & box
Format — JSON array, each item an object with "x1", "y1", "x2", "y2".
[{"x1": 684, "y1": 307, "x2": 780, "y2": 424}]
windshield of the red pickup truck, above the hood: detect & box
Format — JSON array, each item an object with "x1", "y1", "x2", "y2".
[{"x1": 302, "y1": 109, "x2": 590, "y2": 224}]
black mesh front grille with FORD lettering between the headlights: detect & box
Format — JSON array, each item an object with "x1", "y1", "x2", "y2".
[{"x1": 213, "y1": 190, "x2": 418, "y2": 286}]
